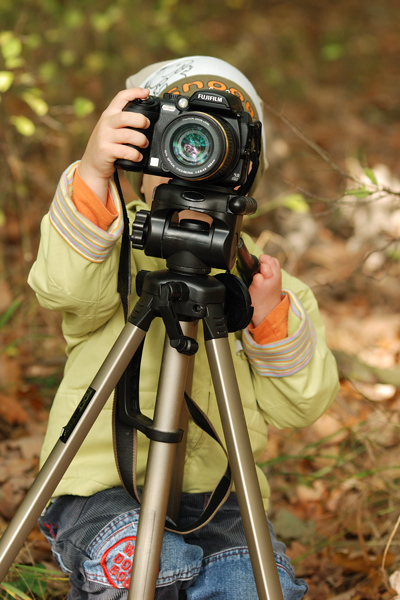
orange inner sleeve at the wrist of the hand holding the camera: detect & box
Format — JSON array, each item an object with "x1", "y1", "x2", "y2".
[{"x1": 72, "y1": 169, "x2": 118, "y2": 231}]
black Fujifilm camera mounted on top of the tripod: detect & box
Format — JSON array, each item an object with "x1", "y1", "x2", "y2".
[{"x1": 115, "y1": 89, "x2": 261, "y2": 188}]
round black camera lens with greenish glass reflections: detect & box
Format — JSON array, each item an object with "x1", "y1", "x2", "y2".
[{"x1": 161, "y1": 112, "x2": 239, "y2": 181}]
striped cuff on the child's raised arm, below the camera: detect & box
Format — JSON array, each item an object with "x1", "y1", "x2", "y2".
[{"x1": 49, "y1": 161, "x2": 124, "y2": 263}]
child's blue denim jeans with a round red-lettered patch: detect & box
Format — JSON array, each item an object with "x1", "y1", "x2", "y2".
[{"x1": 39, "y1": 488, "x2": 307, "y2": 600}]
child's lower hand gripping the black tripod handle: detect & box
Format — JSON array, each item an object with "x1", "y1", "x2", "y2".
[{"x1": 249, "y1": 254, "x2": 282, "y2": 327}]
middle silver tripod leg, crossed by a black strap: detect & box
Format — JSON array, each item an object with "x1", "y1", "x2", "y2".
[{"x1": 128, "y1": 323, "x2": 192, "y2": 600}]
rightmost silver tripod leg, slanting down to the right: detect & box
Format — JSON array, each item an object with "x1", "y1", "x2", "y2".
[{"x1": 205, "y1": 337, "x2": 283, "y2": 600}]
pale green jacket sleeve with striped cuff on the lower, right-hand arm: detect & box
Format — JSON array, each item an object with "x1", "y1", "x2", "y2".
[{"x1": 238, "y1": 232, "x2": 339, "y2": 428}]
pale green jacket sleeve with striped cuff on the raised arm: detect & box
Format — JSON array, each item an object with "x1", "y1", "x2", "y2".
[{"x1": 28, "y1": 163, "x2": 123, "y2": 343}]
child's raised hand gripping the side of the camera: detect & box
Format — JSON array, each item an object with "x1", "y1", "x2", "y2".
[{"x1": 79, "y1": 88, "x2": 150, "y2": 204}]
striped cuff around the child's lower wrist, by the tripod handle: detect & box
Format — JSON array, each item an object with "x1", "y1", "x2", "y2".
[{"x1": 242, "y1": 290, "x2": 316, "y2": 377}]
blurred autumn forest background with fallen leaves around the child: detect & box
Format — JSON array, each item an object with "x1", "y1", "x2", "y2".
[{"x1": 0, "y1": 0, "x2": 400, "y2": 600}]
